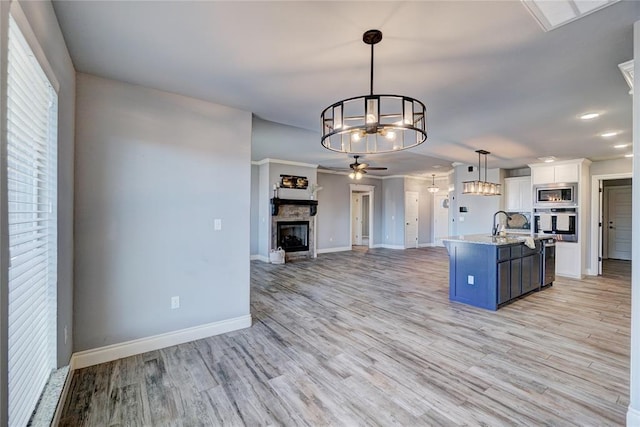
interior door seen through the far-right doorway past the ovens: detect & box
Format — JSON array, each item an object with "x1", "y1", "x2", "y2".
[{"x1": 606, "y1": 185, "x2": 632, "y2": 260}]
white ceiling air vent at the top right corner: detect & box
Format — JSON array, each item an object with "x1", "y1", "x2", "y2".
[{"x1": 521, "y1": 0, "x2": 620, "y2": 31}]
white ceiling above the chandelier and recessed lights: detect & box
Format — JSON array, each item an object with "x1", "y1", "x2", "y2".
[{"x1": 53, "y1": 0, "x2": 640, "y2": 176}]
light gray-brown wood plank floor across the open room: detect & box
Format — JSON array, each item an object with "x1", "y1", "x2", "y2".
[{"x1": 61, "y1": 248, "x2": 631, "y2": 426}]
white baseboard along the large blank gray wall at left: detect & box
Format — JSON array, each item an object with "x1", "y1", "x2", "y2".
[{"x1": 69, "y1": 314, "x2": 251, "y2": 371}]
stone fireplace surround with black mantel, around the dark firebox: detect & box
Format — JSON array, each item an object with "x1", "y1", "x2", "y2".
[{"x1": 271, "y1": 199, "x2": 318, "y2": 261}]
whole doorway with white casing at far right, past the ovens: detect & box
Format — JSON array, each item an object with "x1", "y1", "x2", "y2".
[{"x1": 589, "y1": 173, "x2": 633, "y2": 276}]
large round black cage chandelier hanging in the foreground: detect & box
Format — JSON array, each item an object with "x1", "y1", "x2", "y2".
[{"x1": 320, "y1": 30, "x2": 427, "y2": 154}]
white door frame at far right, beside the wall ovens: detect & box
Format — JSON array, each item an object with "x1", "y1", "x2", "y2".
[{"x1": 580, "y1": 172, "x2": 633, "y2": 276}]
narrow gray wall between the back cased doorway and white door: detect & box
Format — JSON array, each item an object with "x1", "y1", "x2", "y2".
[{"x1": 382, "y1": 178, "x2": 404, "y2": 247}]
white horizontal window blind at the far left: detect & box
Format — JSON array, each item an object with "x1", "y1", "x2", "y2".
[{"x1": 7, "y1": 17, "x2": 58, "y2": 426}]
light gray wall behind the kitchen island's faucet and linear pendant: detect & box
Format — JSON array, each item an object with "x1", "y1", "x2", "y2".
[{"x1": 450, "y1": 165, "x2": 503, "y2": 235}]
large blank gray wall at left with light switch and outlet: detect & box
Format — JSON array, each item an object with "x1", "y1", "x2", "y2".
[{"x1": 74, "y1": 74, "x2": 251, "y2": 351}]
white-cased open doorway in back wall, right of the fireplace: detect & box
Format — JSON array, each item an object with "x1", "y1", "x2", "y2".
[{"x1": 349, "y1": 184, "x2": 375, "y2": 250}]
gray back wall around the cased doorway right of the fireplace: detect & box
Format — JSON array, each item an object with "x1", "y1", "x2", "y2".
[{"x1": 316, "y1": 173, "x2": 382, "y2": 250}]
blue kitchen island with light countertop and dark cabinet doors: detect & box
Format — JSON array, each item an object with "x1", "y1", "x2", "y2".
[{"x1": 443, "y1": 234, "x2": 544, "y2": 310}]
